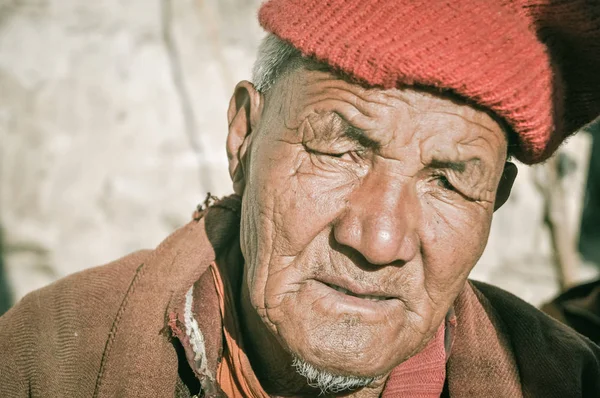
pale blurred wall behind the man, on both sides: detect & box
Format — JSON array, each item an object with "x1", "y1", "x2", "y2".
[{"x1": 0, "y1": 0, "x2": 600, "y2": 313}]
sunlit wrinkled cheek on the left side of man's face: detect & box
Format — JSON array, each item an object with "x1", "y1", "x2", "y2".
[{"x1": 241, "y1": 142, "x2": 360, "y2": 308}]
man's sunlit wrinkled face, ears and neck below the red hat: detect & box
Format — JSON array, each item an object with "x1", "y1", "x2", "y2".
[{"x1": 227, "y1": 69, "x2": 516, "y2": 396}]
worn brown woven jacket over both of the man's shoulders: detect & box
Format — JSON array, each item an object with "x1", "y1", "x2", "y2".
[{"x1": 0, "y1": 197, "x2": 600, "y2": 398}]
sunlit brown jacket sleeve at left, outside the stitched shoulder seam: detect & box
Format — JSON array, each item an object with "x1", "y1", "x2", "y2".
[{"x1": 0, "y1": 251, "x2": 150, "y2": 397}]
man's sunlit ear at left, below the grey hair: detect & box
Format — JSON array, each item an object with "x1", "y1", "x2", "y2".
[{"x1": 226, "y1": 80, "x2": 263, "y2": 195}]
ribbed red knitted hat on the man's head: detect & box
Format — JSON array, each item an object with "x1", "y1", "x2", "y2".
[{"x1": 259, "y1": 0, "x2": 600, "y2": 164}]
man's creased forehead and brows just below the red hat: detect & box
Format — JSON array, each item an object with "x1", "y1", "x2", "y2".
[{"x1": 270, "y1": 67, "x2": 507, "y2": 169}]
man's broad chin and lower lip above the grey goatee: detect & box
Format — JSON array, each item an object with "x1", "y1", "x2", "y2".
[{"x1": 271, "y1": 282, "x2": 423, "y2": 379}]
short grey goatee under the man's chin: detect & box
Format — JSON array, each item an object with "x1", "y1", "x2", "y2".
[{"x1": 292, "y1": 357, "x2": 379, "y2": 394}]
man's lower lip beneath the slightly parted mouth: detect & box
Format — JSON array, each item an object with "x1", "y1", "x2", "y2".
[{"x1": 311, "y1": 280, "x2": 401, "y2": 316}]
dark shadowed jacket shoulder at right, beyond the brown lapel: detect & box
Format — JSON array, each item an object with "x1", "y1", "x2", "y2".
[{"x1": 471, "y1": 281, "x2": 600, "y2": 396}]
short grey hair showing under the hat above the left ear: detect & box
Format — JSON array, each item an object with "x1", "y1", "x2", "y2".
[{"x1": 252, "y1": 33, "x2": 316, "y2": 93}]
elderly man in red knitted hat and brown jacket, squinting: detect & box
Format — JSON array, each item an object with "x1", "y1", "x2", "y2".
[{"x1": 0, "y1": 0, "x2": 600, "y2": 397}]
